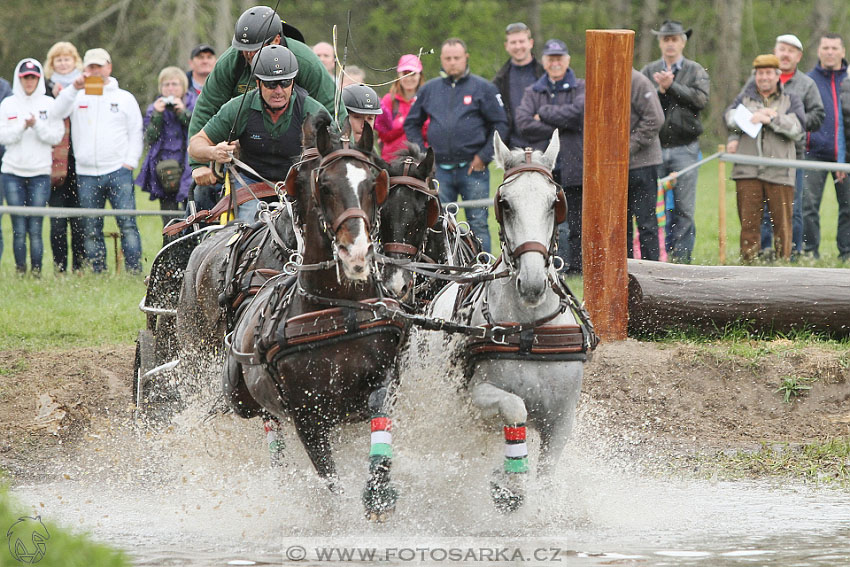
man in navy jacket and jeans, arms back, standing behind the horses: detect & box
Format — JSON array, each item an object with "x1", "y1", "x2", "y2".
[{"x1": 404, "y1": 38, "x2": 508, "y2": 251}]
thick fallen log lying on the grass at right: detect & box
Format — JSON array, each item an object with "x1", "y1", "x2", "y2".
[{"x1": 628, "y1": 260, "x2": 850, "y2": 335}]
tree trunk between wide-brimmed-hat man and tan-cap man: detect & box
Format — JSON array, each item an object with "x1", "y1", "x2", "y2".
[{"x1": 709, "y1": 0, "x2": 744, "y2": 143}]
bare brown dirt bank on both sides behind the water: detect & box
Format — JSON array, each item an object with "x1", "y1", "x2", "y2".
[{"x1": 0, "y1": 340, "x2": 850, "y2": 477}]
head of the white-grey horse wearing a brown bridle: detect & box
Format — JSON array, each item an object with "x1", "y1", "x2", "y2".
[{"x1": 494, "y1": 131, "x2": 567, "y2": 307}]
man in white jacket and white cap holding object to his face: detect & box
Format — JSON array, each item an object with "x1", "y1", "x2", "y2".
[{"x1": 54, "y1": 48, "x2": 142, "y2": 273}]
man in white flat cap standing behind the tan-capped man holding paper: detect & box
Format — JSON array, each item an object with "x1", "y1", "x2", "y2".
[{"x1": 741, "y1": 33, "x2": 824, "y2": 257}]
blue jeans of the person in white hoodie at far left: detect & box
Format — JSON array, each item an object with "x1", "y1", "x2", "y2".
[{"x1": 3, "y1": 173, "x2": 50, "y2": 272}]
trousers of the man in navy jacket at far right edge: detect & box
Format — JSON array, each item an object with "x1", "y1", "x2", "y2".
[{"x1": 803, "y1": 165, "x2": 850, "y2": 260}]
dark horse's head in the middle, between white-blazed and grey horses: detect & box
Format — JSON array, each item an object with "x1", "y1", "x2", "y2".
[{"x1": 379, "y1": 145, "x2": 440, "y2": 300}]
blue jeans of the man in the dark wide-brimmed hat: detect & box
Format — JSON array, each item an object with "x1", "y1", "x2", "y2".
[{"x1": 658, "y1": 141, "x2": 699, "y2": 264}]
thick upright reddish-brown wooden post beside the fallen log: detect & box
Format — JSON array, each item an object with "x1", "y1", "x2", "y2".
[{"x1": 582, "y1": 30, "x2": 635, "y2": 341}]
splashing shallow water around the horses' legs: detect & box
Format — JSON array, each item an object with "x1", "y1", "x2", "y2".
[{"x1": 6, "y1": 330, "x2": 850, "y2": 566}]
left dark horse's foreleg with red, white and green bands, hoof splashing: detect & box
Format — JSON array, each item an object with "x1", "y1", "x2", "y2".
[{"x1": 363, "y1": 382, "x2": 398, "y2": 522}]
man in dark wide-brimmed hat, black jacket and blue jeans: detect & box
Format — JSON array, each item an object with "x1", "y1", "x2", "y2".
[{"x1": 641, "y1": 20, "x2": 709, "y2": 263}]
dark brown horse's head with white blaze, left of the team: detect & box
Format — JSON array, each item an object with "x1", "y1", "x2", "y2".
[{"x1": 287, "y1": 114, "x2": 388, "y2": 281}]
